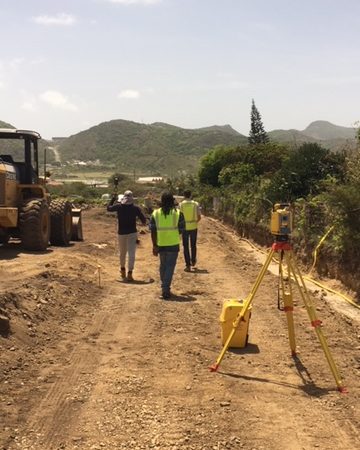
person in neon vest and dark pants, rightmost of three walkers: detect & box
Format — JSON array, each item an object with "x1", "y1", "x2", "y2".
[{"x1": 180, "y1": 190, "x2": 201, "y2": 272}]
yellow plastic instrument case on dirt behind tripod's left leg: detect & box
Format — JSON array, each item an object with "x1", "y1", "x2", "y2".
[{"x1": 220, "y1": 299, "x2": 251, "y2": 348}]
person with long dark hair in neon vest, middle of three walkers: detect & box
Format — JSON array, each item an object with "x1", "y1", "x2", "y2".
[{"x1": 150, "y1": 192, "x2": 185, "y2": 300}]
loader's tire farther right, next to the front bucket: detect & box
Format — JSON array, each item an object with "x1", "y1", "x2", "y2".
[{"x1": 50, "y1": 200, "x2": 72, "y2": 246}]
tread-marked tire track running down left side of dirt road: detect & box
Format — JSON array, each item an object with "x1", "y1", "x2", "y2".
[{"x1": 9, "y1": 289, "x2": 130, "y2": 450}]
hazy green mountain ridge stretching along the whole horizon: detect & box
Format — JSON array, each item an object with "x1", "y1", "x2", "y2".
[{"x1": 0, "y1": 119, "x2": 356, "y2": 175}]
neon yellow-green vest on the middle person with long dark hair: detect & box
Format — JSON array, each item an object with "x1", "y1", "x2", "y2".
[{"x1": 152, "y1": 208, "x2": 180, "y2": 247}]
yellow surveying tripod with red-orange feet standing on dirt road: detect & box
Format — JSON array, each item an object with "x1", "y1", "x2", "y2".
[{"x1": 210, "y1": 238, "x2": 347, "y2": 393}]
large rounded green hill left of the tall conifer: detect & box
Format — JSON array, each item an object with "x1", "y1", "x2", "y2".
[{"x1": 58, "y1": 120, "x2": 247, "y2": 174}]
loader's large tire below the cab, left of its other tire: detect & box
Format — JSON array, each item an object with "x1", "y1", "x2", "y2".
[{"x1": 19, "y1": 199, "x2": 50, "y2": 251}]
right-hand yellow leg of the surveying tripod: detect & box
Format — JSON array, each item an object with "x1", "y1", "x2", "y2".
[{"x1": 288, "y1": 251, "x2": 347, "y2": 393}]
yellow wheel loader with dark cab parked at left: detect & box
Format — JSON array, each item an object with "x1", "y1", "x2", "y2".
[{"x1": 0, "y1": 129, "x2": 82, "y2": 251}]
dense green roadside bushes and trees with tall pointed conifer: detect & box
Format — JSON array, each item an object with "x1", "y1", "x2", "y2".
[{"x1": 173, "y1": 103, "x2": 360, "y2": 293}]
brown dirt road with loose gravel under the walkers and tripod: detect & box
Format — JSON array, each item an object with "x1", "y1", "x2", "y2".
[{"x1": 0, "y1": 209, "x2": 360, "y2": 450}]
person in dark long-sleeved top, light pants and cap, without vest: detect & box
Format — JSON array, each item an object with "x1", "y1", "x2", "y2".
[{"x1": 107, "y1": 191, "x2": 146, "y2": 281}]
